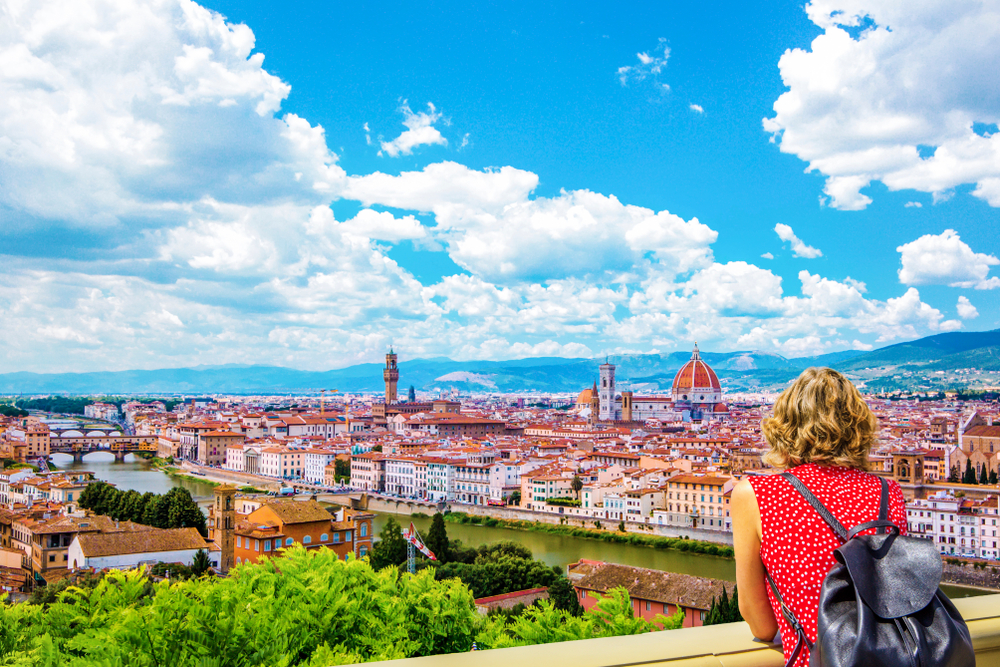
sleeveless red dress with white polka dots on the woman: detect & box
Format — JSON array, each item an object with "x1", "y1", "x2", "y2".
[{"x1": 749, "y1": 463, "x2": 906, "y2": 666}]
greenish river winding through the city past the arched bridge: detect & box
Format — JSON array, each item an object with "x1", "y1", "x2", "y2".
[{"x1": 53, "y1": 453, "x2": 981, "y2": 597}]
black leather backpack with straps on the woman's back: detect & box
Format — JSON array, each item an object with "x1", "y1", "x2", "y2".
[{"x1": 767, "y1": 472, "x2": 976, "y2": 667}]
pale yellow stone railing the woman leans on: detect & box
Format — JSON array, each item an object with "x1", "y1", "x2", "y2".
[{"x1": 366, "y1": 595, "x2": 1000, "y2": 667}]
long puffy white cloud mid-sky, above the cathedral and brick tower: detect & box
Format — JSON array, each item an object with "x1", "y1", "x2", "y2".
[{"x1": 346, "y1": 162, "x2": 718, "y2": 282}]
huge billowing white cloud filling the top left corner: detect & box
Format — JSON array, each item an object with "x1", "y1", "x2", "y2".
[{"x1": 0, "y1": 0, "x2": 343, "y2": 230}]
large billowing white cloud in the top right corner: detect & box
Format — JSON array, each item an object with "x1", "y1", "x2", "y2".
[{"x1": 764, "y1": 0, "x2": 1000, "y2": 210}]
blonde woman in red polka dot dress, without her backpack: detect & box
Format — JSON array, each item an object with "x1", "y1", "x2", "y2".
[{"x1": 731, "y1": 368, "x2": 906, "y2": 665}]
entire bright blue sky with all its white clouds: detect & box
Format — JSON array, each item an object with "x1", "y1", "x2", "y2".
[{"x1": 0, "y1": 0, "x2": 1000, "y2": 371}]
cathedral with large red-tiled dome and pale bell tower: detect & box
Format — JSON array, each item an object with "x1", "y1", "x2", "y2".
[{"x1": 581, "y1": 343, "x2": 729, "y2": 422}]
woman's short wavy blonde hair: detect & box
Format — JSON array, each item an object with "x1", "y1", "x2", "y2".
[{"x1": 761, "y1": 368, "x2": 878, "y2": 470}]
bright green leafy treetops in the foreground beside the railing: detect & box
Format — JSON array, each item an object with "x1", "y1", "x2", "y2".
[{"x1": 0, "y1": 546, "x2": 682, "y2": 667}]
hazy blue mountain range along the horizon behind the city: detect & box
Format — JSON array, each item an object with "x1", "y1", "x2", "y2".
[{"x1": 0, "y1": 329, "x2": 1000, "y2": 396}]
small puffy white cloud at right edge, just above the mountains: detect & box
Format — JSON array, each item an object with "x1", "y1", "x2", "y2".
[{"x1": 896, "y1": 229, "x2": 1000, "y2": 289}]
